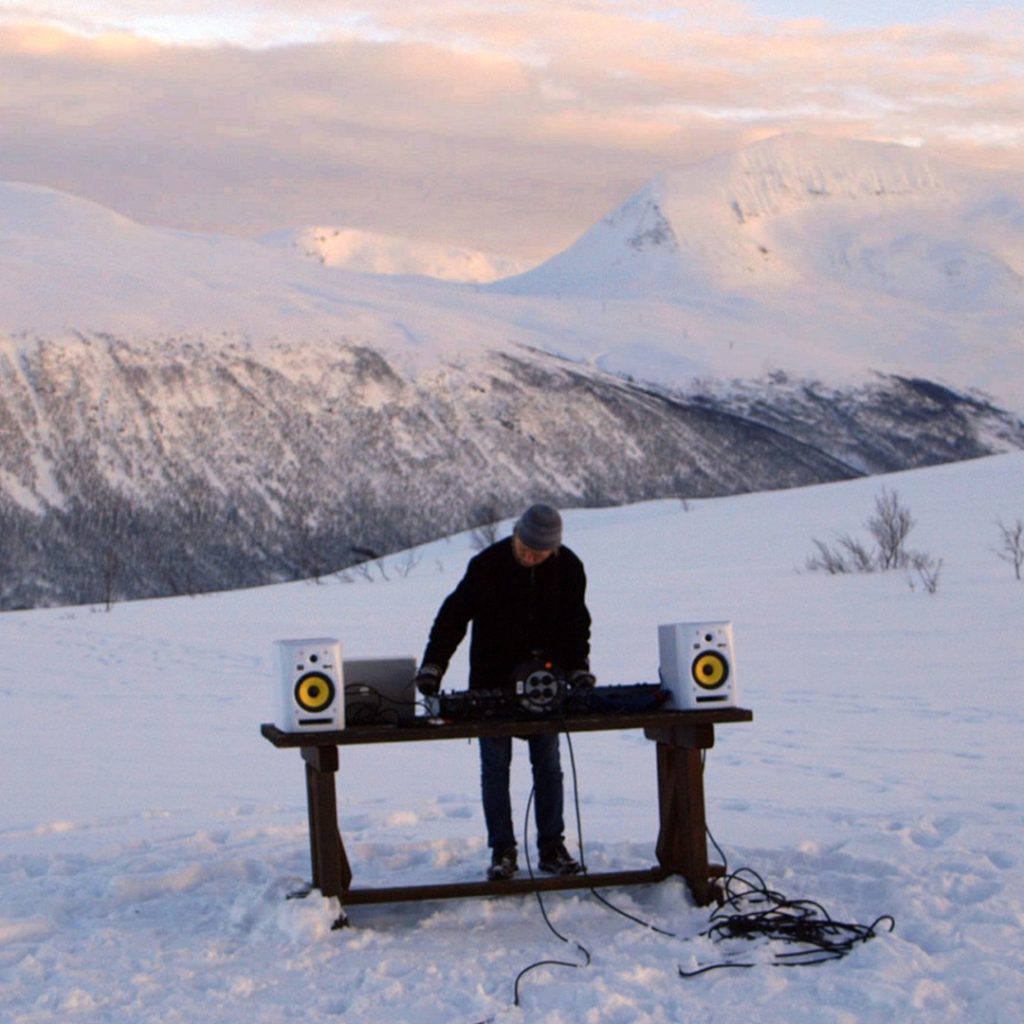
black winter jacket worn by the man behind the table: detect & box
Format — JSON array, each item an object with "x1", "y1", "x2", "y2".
[{"x1": 423, "y1": 538, "x2": 590, "y2": 689}]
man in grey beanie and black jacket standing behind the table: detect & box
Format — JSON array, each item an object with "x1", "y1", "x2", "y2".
[{"x1": 416, "y1": 505, "x2": 594, "y2": 880}]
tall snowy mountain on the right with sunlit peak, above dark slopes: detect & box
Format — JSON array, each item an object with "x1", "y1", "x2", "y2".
[{"x1": 490, "y1": 136, "x2": 1024, "y2": 403}]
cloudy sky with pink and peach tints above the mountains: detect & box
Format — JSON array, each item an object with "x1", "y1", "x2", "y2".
[{"x1": 0, "y1": 0, "x2": 1024, "y2": 258}]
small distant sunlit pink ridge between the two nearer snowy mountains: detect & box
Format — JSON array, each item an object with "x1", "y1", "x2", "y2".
[{"x1": 261, "y1": 227, "x2": 526, "y2": 284}]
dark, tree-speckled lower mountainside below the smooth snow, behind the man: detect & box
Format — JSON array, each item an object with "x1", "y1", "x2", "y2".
[{"x1": 0, "y1": 334, "x2": 1024, "y2": 607}]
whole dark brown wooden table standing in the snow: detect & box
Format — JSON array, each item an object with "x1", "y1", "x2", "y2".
[{"x1": 260, "y1": 708, "x2": 754, "y2": 906}]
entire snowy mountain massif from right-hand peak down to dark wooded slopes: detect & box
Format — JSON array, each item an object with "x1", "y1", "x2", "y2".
[{"x1": 0, "y1": 137, "x2": 1024, "y2": 607}]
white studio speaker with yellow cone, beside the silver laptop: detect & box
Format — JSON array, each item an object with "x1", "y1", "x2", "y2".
[{"x1": 273, "y1": 637, "x2": 345, "y2": 732}]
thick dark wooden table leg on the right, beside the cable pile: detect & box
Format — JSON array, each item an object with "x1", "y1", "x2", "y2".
[{"x1": 645, "y1": 725, "x2": 715, "y2": 906}]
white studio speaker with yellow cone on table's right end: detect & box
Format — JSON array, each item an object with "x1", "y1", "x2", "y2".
[{"x1": 657, "y1": 622, "x2": 738, "y2": 711}]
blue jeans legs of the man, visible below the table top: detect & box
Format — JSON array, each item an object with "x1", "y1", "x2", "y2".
[{"x1": 479, "y1": 733, "x2": 565, "y2": 850}]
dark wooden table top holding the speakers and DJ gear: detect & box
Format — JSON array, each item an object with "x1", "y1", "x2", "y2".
[{"x1": 260, "y1": 708, "x2": 754, "y2": 748}]
